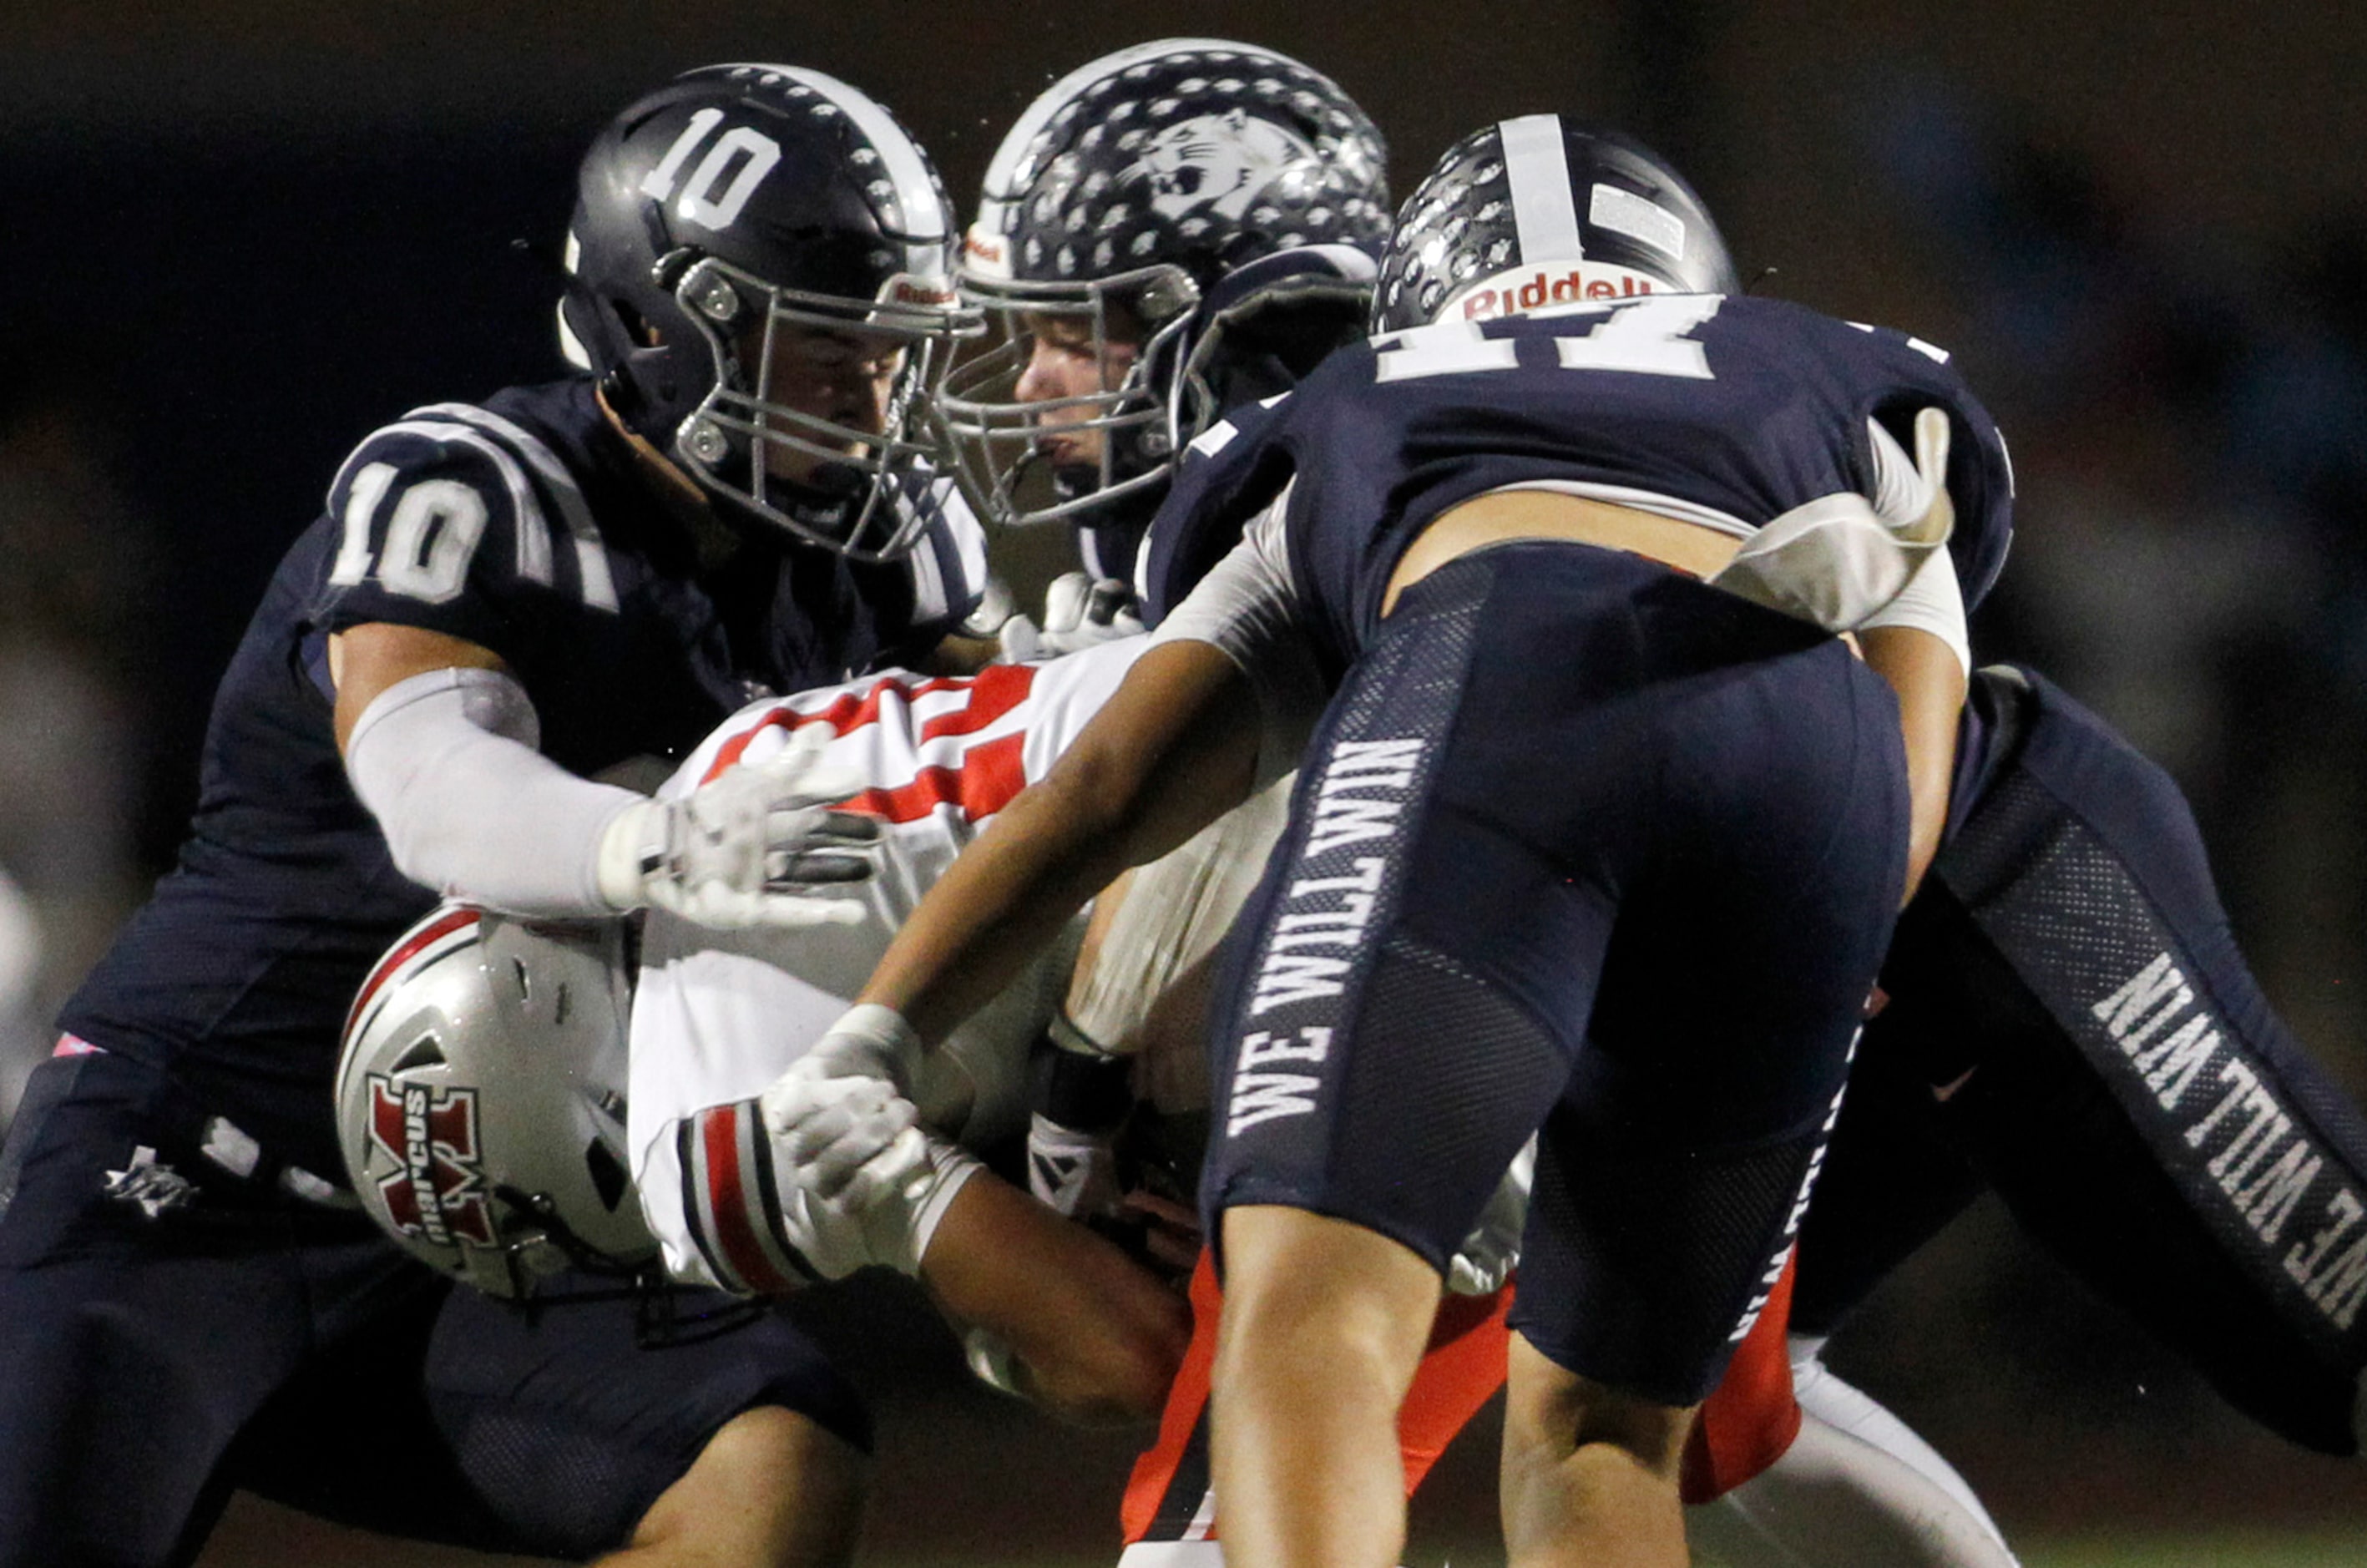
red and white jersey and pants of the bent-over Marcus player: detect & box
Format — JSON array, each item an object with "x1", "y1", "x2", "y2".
[{"x1": 627, "y1": 637, "x2": 1799, "y2": 1568}]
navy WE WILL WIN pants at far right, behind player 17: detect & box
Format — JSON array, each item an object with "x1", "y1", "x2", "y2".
[{"x1": 1792, "y1": 665, "x2": 2367, "y2": 1454}]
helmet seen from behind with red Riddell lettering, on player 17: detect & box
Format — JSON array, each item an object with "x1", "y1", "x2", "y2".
[{"x1": 1373, "y1": 114, "x2": 1740, "y2": 331}]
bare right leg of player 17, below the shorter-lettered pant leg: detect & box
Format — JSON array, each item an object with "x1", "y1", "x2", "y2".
[{"x1": 1503, "y1": 1333, "x2": 1695, "y2": 1568}]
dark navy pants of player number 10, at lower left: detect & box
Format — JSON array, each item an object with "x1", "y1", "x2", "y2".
[{"x1": 0, "y1": 1054, "x2": 868, "y2": 1568}]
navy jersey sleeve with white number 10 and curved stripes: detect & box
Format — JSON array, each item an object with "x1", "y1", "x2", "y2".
[{"x1": 312, "y1": 402, "x2": 618, "y2": 660}]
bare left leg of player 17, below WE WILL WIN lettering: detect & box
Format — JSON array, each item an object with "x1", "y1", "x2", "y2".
[{"x1": 1210, "y1": 1206, "x2": 1439, "y2": 1568}]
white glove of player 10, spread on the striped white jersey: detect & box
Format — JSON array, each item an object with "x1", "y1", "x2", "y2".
[{"x1": 599, "y1": 725, "x2": 878, "y2": 931}]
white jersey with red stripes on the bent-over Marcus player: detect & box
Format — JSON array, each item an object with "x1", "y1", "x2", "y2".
[{"x1": 627, "y1": 637, "x2": 1146, "y2": 1284}]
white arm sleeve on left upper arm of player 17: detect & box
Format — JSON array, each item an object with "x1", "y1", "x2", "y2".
[{"x1": 1151, "y1": 486, "x2": 1330, "y2": 787}]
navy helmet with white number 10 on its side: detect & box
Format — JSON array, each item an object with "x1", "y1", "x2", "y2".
[{"x1": 559, "y1": 64, "x2": 978, "y2": 561}]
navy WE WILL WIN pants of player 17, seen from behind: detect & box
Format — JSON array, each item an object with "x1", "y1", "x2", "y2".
[{"x1": 1202, "y1": 543, "x2": 1905, "y2": 1404}]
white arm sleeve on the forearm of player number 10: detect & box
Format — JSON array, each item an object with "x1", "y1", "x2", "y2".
[{"x1": 346, "y1": 668, "x2": 641, "y2": 919}]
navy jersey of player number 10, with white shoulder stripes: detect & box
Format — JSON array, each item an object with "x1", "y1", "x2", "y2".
[{"x1": 62, "y1": 379, "x2": 984, "y2": 1175}]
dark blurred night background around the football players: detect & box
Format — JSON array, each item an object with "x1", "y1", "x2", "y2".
[{"x1": 0, "y1": 0, "x2": 2367, "y2": 1568}]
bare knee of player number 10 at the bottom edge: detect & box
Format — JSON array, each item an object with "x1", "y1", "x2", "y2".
[{"x1": 599, "y1": 1404, "x2": 871, "y2": 1568}]
